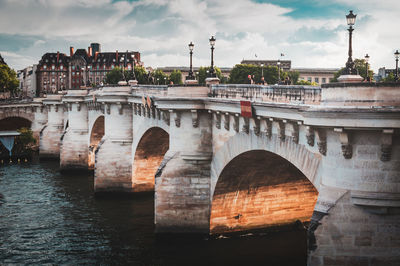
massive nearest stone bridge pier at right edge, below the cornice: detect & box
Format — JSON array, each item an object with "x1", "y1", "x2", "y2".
[{"x1": 308, "y1": 130, "x2": 400, "y2": 266}]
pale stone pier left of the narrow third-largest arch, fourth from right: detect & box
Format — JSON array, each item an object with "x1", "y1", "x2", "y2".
[{"x1": 60, "y1": 90, "x2": 89, "y2": 171}]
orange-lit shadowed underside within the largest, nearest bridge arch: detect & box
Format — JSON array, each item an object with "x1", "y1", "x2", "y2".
[{"x1": 210, "y1": 150, "x2": 318, "y2": 234}]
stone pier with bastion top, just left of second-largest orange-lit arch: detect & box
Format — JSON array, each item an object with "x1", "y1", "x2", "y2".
[{"x1": 94, "y1": 87, "x2": 132, "y2": 193}]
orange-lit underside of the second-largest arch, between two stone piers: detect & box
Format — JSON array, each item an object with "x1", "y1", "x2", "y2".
[{"x1": 132, "y1": 127, "x2": 169, "y2": 192}]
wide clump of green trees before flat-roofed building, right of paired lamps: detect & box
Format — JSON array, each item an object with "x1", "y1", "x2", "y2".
[{"x1": 229, "y1": 64, "x2": 282, "y2": 84}]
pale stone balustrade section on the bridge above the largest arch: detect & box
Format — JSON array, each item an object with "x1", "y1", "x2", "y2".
[{"x1": 211, "y1": 84, "x2": 321, "y2": 105}]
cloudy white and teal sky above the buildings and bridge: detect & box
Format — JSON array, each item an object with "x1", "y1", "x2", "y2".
[{"x1": 0, "y1": 0, "x2": 400, "y2": 71}]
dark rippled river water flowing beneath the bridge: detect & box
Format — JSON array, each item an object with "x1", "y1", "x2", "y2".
[{"x1": 0, "y1": 162, "x2": 306, "y2": 265}]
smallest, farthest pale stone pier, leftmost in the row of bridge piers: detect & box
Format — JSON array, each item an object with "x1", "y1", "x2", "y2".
[{"x1": 39, "y1": 95, "x2": 64, "y2": 159}]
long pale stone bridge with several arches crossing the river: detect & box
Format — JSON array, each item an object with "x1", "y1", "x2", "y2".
[{"x1": 0, "y1": 83, "x2": 400, "y2": 265}]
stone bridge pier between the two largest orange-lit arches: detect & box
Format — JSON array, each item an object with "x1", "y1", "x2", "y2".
[{"x1": 155, "y1": 110, "x2": 212, "y2": 234}]
